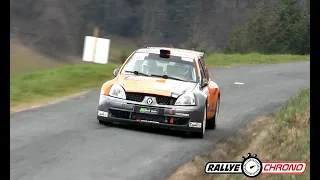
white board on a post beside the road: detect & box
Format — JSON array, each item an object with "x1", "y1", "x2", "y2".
[{"x1": 82, "y1": 36, "x2": 110, "y2": 64}]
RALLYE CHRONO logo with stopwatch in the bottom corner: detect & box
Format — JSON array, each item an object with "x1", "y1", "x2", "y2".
[{"x1": 204, "y1": 153, "x2": 307, "y2": 178}]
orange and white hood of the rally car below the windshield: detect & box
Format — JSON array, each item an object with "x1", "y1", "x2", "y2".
[{"x1": 116, "y1": 74, "x2": 197, "y2": 96}]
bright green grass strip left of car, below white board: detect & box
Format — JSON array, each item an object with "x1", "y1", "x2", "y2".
[{"x1": 10, "y1": 63, "x2": 120, "y2": 107}]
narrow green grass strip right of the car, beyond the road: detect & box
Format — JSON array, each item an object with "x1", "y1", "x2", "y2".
[{"x1": 205, "y1": 53, "x2": 310, "y2": 67}]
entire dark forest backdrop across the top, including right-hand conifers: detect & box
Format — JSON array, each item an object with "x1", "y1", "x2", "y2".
[{"x1": 10, "y1": 0, "x2": 310, "y2": 57}]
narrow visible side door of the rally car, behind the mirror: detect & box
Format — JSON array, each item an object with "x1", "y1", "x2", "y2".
[{"x1": 198, "y1": 59, "x2": 215, "y2": 118}]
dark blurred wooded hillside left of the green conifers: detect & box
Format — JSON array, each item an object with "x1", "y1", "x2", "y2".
[{"x1": 10, "y1": 0, "x2": 252, "y2": 56}]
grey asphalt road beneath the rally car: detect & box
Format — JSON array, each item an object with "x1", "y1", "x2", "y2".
[{"x1": 10, "y1": 62, "x2": 310, "y2": 180}]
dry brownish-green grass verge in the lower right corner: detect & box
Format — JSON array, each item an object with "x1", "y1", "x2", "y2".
[{"x1": 168, "y1": 87, "x2": 310, "y2": 180}]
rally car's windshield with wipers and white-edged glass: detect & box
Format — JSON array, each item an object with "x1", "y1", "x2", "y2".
[{"x1": 121, "y1": 52, "x2": 197, "y2": 82}]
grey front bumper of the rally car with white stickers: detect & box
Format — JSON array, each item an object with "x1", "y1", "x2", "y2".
[{"x1": 97, "y1": 95, "x2": 204, "y2": 132}]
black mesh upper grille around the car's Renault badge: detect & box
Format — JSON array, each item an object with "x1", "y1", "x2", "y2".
[{"x1": 126, "y1": 92, "x2": 177, "y2": 105}]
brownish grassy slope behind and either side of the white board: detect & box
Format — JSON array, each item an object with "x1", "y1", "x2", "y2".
[{"x1": 10, "y1": 36, "x2": 138, "y2": 77}]
